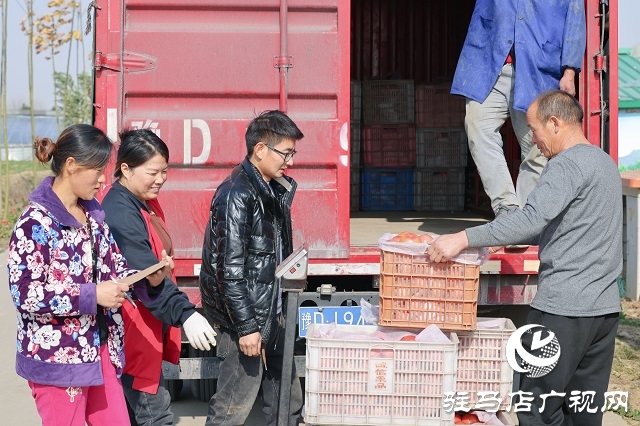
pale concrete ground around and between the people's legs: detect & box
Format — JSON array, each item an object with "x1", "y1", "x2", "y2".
[{"x1": 0, "y1": 248, "x2": 628, "y2": 426}]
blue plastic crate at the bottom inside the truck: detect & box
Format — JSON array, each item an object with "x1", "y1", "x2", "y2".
[{"x1": 360, "y1": 167, "x2": 413, "y2": 211}]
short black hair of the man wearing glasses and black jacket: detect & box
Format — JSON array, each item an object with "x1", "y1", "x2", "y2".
[{"x1": 244, "y1": 110, "x2": 304, "y2": 156}]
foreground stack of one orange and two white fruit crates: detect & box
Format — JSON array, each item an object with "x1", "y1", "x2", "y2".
[{"x1": 305, "y1": 238, "x2": 515, "y2": 426}]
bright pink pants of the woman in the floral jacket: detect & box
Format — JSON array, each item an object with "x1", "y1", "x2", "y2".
[{"x1": 29, "y1": 344, "x2": 130, "y2": 426}]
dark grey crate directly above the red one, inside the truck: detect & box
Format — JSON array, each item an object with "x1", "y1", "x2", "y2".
[{"x1": 362, "y1": 80, "x2": 415, "y2": 124}]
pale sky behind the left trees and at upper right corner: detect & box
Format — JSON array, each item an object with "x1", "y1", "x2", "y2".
[{"x1": 0, "y1": 0, "x2": 640, "y2": 109}]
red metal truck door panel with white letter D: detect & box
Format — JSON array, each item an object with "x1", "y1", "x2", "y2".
[{"x1": 95, "y1": 0, "x2": 350, "y2": 275}]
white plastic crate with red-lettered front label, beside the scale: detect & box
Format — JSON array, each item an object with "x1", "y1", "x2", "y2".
[{"x1": 304, "y1": 324, "x2": 458, "y2": 426}]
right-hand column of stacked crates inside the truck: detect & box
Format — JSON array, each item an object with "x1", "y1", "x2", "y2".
[{"x1": 414, "y1": 83, "x2": 467, "y2": 211}]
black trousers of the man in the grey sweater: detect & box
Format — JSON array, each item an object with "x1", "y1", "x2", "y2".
[{"x1": 513, "y1": 308, "x2": 619, "y2": 426}]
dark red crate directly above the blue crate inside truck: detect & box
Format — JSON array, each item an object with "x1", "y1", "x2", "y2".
[{"x1": 362, "y1": 126, "x2": 416, "y2": 167}]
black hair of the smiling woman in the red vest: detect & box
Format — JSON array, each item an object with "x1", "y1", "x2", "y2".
[{"x1": 113, "y1": 129, "x2": 169, "y2": 179}]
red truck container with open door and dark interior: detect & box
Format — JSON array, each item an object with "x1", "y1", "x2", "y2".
[{"x1": 94, "y1": 0, "x2": 618, "y2": 400}]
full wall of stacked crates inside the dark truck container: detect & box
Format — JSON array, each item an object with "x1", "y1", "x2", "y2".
[{"x1": 351, "y1": 80, "x2": 467, "y2": 211}]
